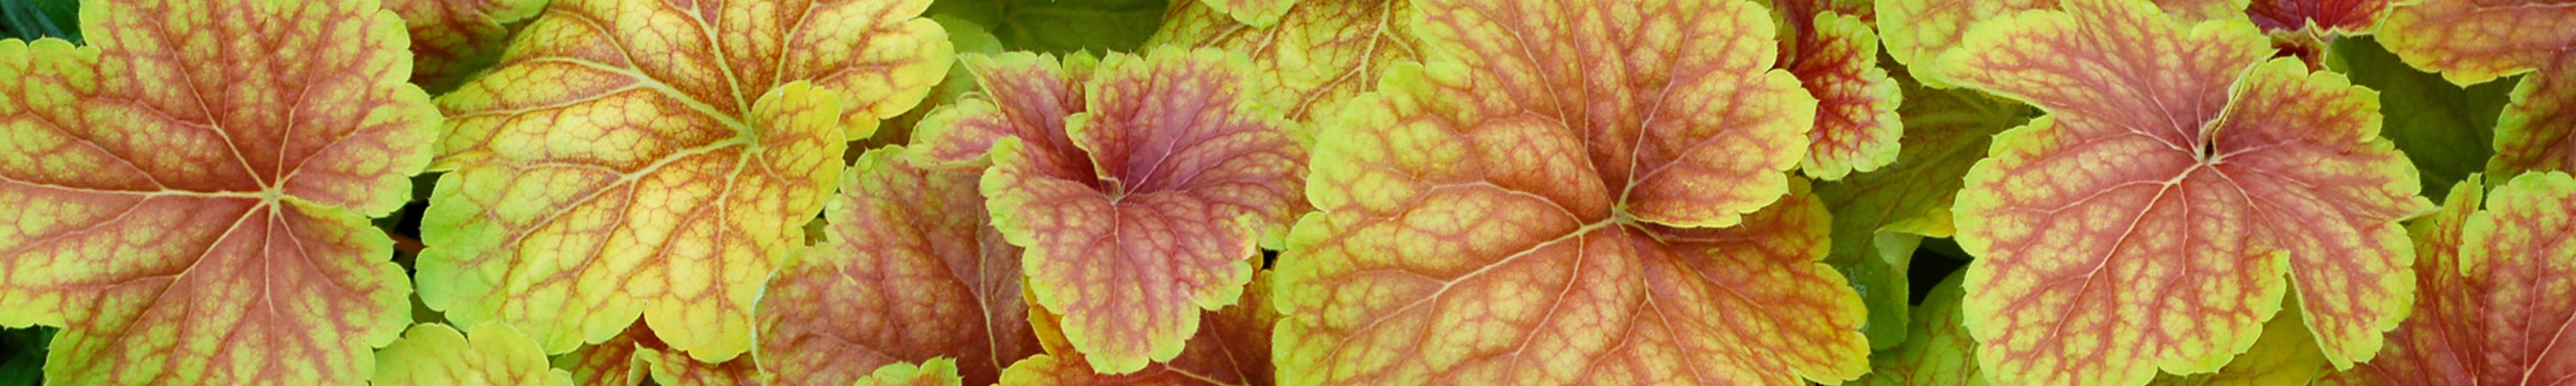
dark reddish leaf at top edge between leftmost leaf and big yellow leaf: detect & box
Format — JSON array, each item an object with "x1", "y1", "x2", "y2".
[{"x1": 384, "y1": 0, "x2": 546, "y2": 93}]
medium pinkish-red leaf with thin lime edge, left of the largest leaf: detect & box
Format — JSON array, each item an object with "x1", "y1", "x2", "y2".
[{"x1": 914, "y1": 46, "x2": 1309, "y2": 373}]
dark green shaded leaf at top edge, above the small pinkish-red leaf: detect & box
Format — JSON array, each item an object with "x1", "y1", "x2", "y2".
[{"x1": 927, "y1": 0, "x2": 1170, "y2": 54}]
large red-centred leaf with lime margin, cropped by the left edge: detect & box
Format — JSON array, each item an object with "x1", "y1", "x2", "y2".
[{"x1": 0, "y1": 0, "x2": 438, "y2": 386}]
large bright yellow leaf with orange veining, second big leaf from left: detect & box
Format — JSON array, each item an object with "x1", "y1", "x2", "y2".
[{"x1": 420, "y1": 0, "x2": 951, "y2": 360}]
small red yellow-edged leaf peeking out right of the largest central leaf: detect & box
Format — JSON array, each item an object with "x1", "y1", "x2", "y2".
[{"x1": 1780, "y1": 0, "x2": 1904, "y2": 180}]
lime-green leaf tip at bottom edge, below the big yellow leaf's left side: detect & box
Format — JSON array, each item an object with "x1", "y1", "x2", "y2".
[{"x1": 374, "y1": 324, "x2": 572, "y2": 386}]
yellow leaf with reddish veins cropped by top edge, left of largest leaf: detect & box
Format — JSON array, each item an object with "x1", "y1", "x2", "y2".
[{"x1": 1146, "y1": 0, "x2": 1419, "y2": 124}]
